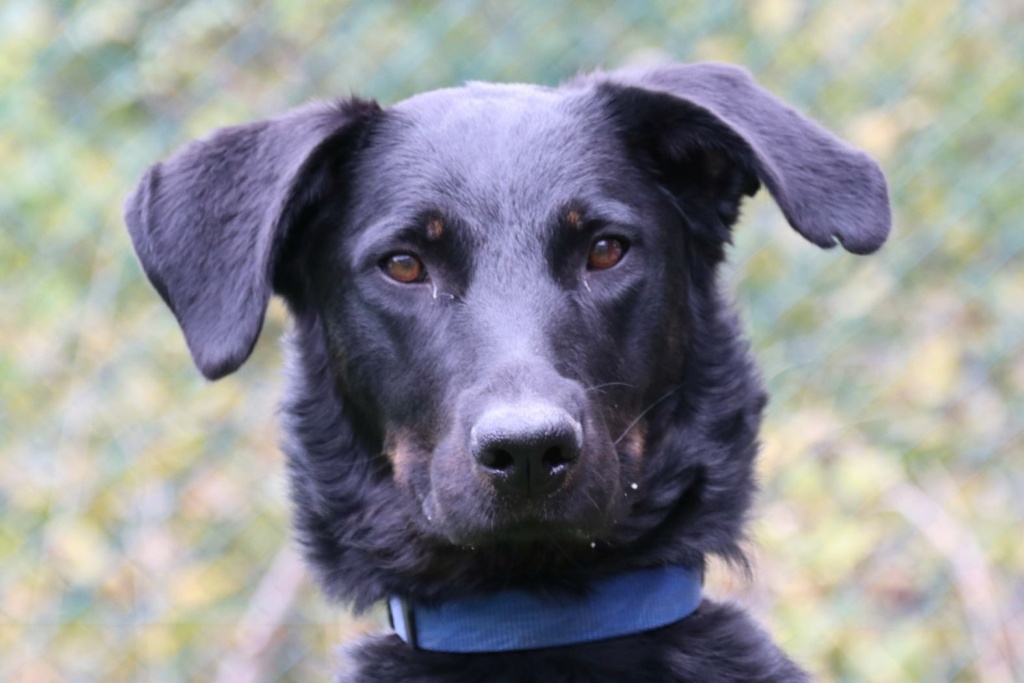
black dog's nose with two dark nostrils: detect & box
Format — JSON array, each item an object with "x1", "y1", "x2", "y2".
[{"x1": 470, "y1": 403, "x2": 583, "y2": 497}]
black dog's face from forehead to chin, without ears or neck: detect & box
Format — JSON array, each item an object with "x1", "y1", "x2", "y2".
[{"x1": 311, "y1": 86, "x2": 686, "y2": 544}]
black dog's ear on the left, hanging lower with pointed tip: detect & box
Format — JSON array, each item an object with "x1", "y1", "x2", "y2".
[{"x1": 125, "y1": 99, "x2": 381, "y2": 380}]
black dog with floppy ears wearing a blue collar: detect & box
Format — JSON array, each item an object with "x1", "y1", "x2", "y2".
[{"x1": 127, "y1": 65, "x2": 890, "y2": 683}]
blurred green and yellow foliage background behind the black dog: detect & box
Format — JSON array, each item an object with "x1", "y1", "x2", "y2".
[{"x1": 0, "y1": 0, "x2": 1024, "y2": 683}]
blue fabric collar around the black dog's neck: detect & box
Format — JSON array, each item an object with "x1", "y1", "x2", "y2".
[{"x1": 388, "y1": 566, "x2": 703, "y2": 652}]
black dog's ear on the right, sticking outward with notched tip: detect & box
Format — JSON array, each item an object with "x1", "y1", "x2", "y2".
[{"x1": 600, "y1": 63, "x2": 891, "y2": 254}]
